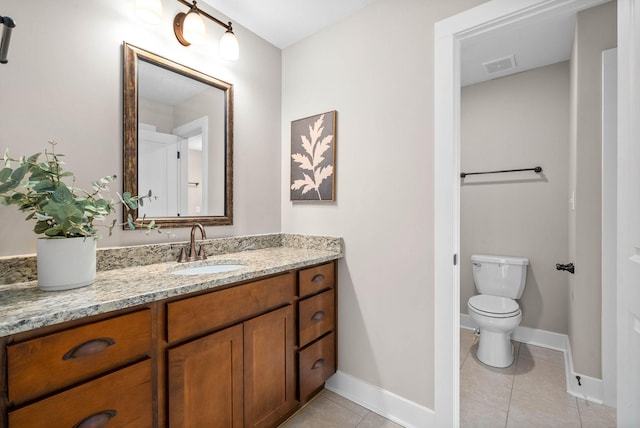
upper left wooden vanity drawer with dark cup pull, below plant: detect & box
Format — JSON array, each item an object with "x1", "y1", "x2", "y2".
[{"x1": 7, "y1": 309, "x2": 151, "y2": 404}]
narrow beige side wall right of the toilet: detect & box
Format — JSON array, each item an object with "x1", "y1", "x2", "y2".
[{"x1": 569, "y1": 1, "x2": 617, "y2": 378}]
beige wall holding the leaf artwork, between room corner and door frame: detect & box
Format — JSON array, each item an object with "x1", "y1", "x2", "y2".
[{"x1": 281, "y1": 0, "x2": 482, "y2": 408}]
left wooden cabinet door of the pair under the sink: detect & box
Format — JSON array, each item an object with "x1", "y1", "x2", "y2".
[{"x1": 168, "y1": 325, "x2": 243, "y2": 428}]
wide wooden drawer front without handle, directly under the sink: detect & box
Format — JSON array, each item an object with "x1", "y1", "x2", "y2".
[{"x1": 167, "y1": 272, "x2": 295, "y2": 343}]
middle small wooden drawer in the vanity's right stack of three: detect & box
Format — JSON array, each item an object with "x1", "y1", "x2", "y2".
[{"x1": 298, "y1": 290, "x2": 335, "y2": 347}]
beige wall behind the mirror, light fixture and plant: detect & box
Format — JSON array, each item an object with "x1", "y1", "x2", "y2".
[{"x1": 0, "y1": 0, "x2": 281, "y2": 256}]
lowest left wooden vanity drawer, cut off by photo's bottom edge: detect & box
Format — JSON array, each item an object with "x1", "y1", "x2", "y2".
[{"x1": 9, "y1": 360, "x2": 153, "y2": 428}]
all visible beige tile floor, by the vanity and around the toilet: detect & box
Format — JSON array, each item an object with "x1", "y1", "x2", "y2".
[{"x1": 280, "y1": 329, "x2": 616, "y2": 428}]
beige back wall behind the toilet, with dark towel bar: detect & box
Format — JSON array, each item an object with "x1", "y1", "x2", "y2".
[{"x1": 460, "y1": 62, "x2": 569, "y2": 334}]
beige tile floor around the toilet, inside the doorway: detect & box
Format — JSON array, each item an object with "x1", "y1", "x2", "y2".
[{"x1": 460, "y1": 329, "x2": 616, "y2": 428}]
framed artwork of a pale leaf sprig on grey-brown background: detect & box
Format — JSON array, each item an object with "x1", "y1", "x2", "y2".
[{"x1": 290, "y1": 110, "x2": 337, "y2": 201}]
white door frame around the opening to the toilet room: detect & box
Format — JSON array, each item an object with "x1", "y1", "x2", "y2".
[{"x1": 434, "y1": 0, "x2": 612, "y2": 427}]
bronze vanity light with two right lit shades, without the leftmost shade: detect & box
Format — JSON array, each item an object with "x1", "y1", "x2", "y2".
[{"x1": 173, "y1": 0, "x2": 240, "y2": 61}]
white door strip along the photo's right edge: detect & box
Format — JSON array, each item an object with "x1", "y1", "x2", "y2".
[{"x1": 617, "y1": 0, "x2": 640, "y2": 427}]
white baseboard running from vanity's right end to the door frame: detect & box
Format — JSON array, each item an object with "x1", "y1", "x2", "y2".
[{"x1": 325, "y1": 370, "x2": 435, "y2": 428}]
